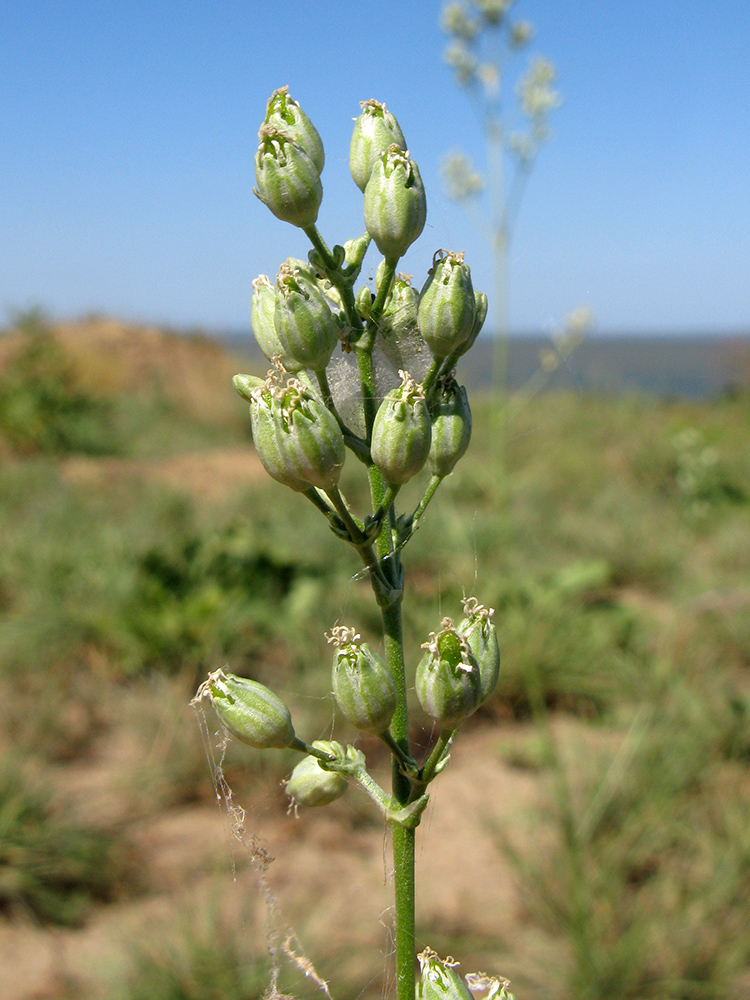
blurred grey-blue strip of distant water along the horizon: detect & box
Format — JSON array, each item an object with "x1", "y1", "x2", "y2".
[{"x1": 219, "y1": 331, "x2": 750, "y2": 399}]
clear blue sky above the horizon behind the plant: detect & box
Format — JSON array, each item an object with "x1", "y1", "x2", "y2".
[{"x1": 0, "y1": 0, "x2": 750, "y2": 332}]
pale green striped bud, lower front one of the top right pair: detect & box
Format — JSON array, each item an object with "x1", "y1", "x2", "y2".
[{"x1": 364, "y1": 144, "x2": 427, "y2": 261}]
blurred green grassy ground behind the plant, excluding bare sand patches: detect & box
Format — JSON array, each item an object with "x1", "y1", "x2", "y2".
[{"x1": 0, "y1": 317, "x2": 750, "y2": 1000}]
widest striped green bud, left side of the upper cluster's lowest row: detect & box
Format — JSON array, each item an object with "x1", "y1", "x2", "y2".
[{"x1": 250, "y1": 377, "x2": 345, "y2": 493}]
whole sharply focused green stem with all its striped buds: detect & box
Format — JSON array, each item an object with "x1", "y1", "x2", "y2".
[{"x1": 196, "y1": 87, "x2": 509, "y2": 1000}]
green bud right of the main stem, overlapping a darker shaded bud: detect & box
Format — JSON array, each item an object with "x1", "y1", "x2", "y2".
[{"x1": 370, "y1": 371, "x2": 431, "y2": 486}]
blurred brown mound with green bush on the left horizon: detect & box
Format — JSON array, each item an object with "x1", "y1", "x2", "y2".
[{"x1": 0, "y1": 308, "x2": 253, "y2": 456}]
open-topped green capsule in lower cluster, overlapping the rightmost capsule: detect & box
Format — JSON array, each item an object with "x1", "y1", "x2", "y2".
[{"x1": 415, "y1": 618, "x2": 481, "y2": 729}]
